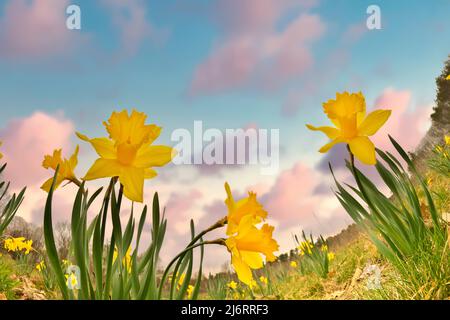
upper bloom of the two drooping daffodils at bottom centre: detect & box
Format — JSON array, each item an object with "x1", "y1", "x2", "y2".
[{"x1": 225, "y1": 183, "x2": 267, "y2": 235}]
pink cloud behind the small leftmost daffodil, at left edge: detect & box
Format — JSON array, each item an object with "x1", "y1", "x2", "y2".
[{"x1": 0, "y1": 112, "x2": 74, "y2": 188}]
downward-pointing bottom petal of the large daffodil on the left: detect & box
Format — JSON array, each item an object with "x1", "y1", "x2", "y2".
[{"x1": 119, "y1": 167, "x2": 145, "y2": 202}]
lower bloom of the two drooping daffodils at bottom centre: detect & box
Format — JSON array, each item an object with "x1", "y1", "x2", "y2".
[{"x1": 225, "y1": 215, "x2": 278, "y2": 286}]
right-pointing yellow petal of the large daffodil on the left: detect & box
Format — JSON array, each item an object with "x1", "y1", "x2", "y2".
[{"x1": 133, "y1": 145, "x2": 175, "y2": 168}]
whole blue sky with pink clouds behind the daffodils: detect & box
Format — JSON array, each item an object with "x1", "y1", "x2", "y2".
[{"x1": 0, "y1": 0, "x2": 450, "y2": 271}]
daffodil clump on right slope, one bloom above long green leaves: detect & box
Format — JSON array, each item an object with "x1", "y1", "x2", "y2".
[{"x1": 305, "y1": 91, "x2": 450, "y2": 297}]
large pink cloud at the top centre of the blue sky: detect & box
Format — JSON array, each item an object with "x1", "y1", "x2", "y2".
[{"x1": 190, "y1": 0, "x2": 325, "y2": 95}]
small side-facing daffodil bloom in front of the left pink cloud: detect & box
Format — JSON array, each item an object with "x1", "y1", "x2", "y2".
[{"x1": 41, "y1": 146, "x2": 79, "y2": 192}]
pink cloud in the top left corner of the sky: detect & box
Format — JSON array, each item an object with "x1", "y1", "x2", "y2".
[{"x1": 0, "y1": 0, "x2": 89, "y2": 59}]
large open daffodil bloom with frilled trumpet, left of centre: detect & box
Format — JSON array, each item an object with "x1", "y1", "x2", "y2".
[{"x1": 77, "y1": 110, "x2": 175, "y2": 202}]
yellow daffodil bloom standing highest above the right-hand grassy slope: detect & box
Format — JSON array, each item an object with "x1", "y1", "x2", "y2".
[{"x1": 306, "y1": 92, "x2": 391, "y2": 165}]
